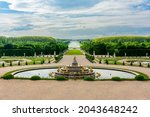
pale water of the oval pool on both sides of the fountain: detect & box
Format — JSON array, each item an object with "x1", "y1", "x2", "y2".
[{"x1": 15, "y1": 69, "x2": 135, "y2": 79}]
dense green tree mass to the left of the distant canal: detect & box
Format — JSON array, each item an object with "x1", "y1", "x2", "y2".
[{"x1": 0, "y1": 36, "x2": 69, "y2": 56}]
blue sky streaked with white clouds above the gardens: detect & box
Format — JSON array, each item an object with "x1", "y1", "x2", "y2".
[{"x1": 0, "y1": 0, "x2": 150, "y2": 39}]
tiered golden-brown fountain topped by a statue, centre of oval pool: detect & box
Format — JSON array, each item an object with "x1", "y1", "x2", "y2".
[{"x1": 55, "y1": 57, "x2": 95, "y2": 79}]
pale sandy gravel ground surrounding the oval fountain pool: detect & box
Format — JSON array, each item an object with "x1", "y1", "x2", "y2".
[{"x1": 0, "y1": 56, "x2": 150, "y2": 99}]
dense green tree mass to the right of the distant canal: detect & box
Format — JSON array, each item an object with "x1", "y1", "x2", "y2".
[{"x1": 81, "y1": 36, "x2": 150, "y2": 56}]
